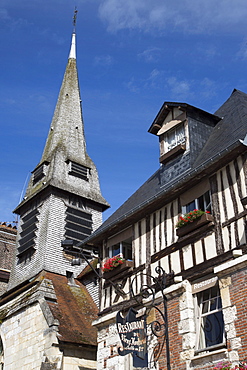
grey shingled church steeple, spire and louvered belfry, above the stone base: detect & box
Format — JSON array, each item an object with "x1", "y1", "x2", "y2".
[{"x1": 9, "y1": 23, "x2": 109, "y2": 288}]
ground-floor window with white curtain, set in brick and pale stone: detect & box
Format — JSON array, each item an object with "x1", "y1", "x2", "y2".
[{"x1": 195, "y1": 285, "x2": 224, "y2": 353}]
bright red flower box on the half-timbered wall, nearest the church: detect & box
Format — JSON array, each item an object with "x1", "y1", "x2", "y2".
[{"x1": 102, "y1": 256, "x2": 134, "y2": 279}]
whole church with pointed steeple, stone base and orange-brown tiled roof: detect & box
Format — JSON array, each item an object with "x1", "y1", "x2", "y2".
[{"x1": 0, "y1": 27, "x2": 109, "y2": 370}]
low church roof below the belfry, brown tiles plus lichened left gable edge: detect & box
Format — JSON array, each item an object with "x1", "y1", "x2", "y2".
[{"x1": 0, "y1": 271, "x2": 98, "y2": 346}]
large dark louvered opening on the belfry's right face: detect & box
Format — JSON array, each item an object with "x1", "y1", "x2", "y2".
[{"x1": 65, "y1": 206, "x2": 93, "y2": 244}]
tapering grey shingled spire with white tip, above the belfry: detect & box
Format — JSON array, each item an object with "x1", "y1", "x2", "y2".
[{"x1": 20, "y1": 33, "x2": 108, "y2": 207}]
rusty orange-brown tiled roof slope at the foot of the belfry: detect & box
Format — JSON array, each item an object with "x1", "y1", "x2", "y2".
[{"x1": 45, "y1": 272, "x2": 98, "y2": 346}]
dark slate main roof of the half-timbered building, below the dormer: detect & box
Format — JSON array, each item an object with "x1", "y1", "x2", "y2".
[{"x1": 84, "y1": 90, "x2": 247, "y2": 243}]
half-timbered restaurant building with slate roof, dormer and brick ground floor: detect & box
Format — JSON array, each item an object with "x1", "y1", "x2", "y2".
[{"x1": 83, "y1": 90, "x2": 247, "y2": 370}]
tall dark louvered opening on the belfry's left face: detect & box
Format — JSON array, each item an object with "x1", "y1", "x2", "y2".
[{"x1": 18, "y1": 209, "x2": 39, "y2": 256}]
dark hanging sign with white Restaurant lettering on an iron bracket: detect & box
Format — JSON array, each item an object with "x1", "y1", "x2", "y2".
[{"x1": 116, "y1": 308, "x2": 147, "y2": 365}]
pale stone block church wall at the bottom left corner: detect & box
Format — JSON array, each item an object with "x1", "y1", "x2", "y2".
[{"x1": 0, "y1": 303, "x2": 62, "y2": 370}]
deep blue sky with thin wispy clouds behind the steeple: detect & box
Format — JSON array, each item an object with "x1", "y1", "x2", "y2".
[{"x1": 0, "y1": 0, "x2": 247, "y2": 222}]
